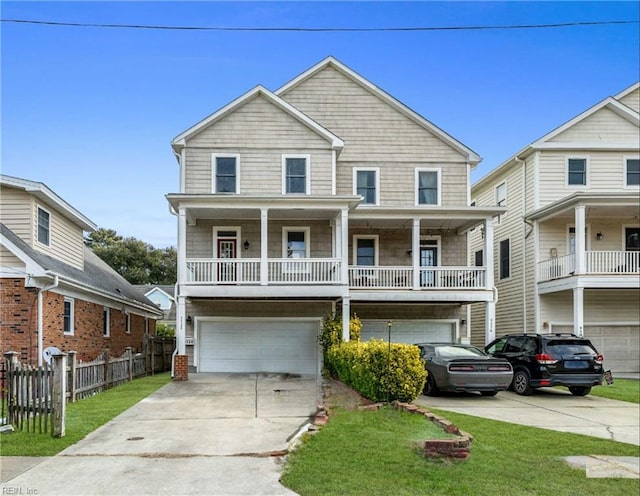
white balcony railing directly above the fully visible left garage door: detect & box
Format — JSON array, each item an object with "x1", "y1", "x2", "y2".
[{"x1": 186, "y1": 258, "x2": 342, "y2": 285}]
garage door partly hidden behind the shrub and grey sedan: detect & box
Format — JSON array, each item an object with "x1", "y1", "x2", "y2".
[{"x1": 361, "y1": 320, "x2": 455, "y2": 344}]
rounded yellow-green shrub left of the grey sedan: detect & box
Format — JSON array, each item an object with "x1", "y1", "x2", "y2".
[{"x1": 325, "y1": 339, "x2": 427, "y2": 401}]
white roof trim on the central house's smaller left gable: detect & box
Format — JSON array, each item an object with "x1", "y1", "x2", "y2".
[{"x1": 171, "y1": 85, "x2": 344, "y2": 150}]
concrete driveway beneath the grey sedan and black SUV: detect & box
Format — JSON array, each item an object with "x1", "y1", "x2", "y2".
[{"x1": 415, "y1": 386, "x2": 640, "y2": 445}]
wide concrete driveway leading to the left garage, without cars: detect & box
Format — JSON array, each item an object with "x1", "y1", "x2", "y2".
[{"x1": 0, "y1": 374, "x2": 320, "y2": 496}]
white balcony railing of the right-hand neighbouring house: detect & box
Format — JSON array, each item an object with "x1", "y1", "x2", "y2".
[{"x1": 538, "y1": 251, "x2": 640, "y2": 282}]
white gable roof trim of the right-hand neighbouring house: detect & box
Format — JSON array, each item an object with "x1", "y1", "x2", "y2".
[{"x1": 471, "y1": 82, "x2": 640, "y2": 189}]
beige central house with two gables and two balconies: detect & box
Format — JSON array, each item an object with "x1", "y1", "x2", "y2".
[{"x1": 167, "y1": 57, "x2": 505, "y2": 375}]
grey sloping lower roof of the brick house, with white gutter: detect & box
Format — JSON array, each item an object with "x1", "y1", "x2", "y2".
[{"x1": 0, "y1": 222, "x2": 162, "y2": 315}]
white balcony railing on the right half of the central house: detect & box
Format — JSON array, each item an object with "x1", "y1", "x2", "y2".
[{"x1": 349, "y1": 266, "x2": 486, "y2": 289}]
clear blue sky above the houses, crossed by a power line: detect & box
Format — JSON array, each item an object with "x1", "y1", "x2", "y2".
[{"x1": 0, "y1": 1, "x2": 640, "y2": 247}]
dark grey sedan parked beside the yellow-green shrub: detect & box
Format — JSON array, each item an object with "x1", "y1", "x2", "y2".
[{"x1": 416, "y1": 343, "x2": 513, "y2": 396}]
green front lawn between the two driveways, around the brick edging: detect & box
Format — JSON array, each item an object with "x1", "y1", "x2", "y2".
[{"x1": 282, "y1": 404, "x2": 640, "y2": 496}]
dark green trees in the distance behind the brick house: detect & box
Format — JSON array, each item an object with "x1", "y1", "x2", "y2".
[{"x1": 85, "y1": 228, "x2": 178, "y2": 284}]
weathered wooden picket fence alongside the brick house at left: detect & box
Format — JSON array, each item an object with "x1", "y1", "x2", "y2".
[{"x1": 0, "y1": 337, "x2": 175, "y2": 436}]
